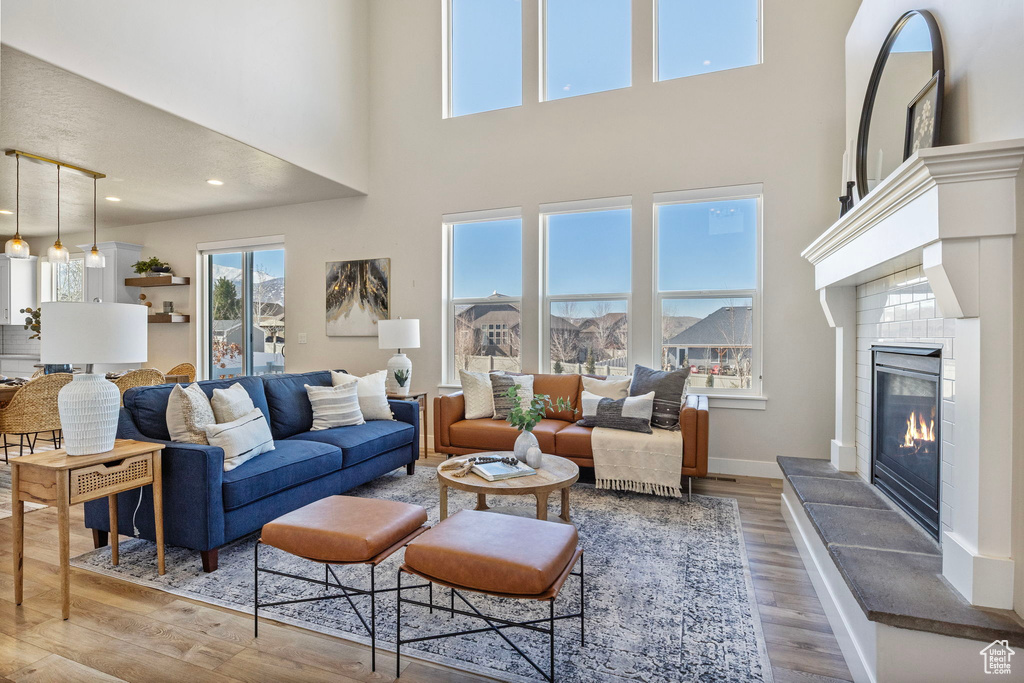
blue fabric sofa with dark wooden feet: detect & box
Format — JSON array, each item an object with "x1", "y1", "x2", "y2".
[{"x1": 85, "y1": 371, "x2": 420, "y2": 571}]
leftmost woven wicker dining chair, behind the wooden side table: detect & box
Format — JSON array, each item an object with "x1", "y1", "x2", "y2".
[{"x1": 0, "y1": 373, "x2": 72, "y2": 462}]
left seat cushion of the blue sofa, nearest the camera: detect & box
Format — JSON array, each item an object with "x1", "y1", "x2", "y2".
[{"x1": 222, "y1": 440, "x2": 343, "y2": 510}]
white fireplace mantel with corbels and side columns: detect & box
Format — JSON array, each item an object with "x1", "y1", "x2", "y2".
[{"x1": 802, "y1": 139, "x2": 1024, "y2": 609}]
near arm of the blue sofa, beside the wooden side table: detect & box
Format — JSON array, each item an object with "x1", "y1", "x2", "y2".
[{"x1": 85, "y1": 409, "x2": 224, "y2": 550}]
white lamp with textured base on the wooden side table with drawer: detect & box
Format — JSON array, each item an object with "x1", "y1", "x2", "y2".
[{"x1": 40, "y1": 302, "x2": 148, "y2": 456}]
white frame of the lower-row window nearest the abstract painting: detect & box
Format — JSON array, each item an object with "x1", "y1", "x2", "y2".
[{"x1": 440, "y1": 205, "x2": 525, "y2": 386}]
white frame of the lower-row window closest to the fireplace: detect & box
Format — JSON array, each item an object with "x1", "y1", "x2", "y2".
[{"x1": 651, "y1": 183, "x2": 764, "y2": 398}]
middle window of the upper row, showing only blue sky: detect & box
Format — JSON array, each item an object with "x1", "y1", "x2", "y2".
[{"x1": 541, "y1": 0, "x2": 633, "y2": 99}]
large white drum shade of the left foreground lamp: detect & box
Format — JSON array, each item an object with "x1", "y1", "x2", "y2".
[{"x1": 40, "y1": 302, "x2": 148, "y2": 365}]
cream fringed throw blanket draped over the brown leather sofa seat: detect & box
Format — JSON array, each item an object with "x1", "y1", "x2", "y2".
[{"x1": 590, "y1": 427, "x2": 683, "y2": 498}]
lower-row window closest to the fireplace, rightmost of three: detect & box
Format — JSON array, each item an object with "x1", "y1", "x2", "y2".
[{"x1": 654, "y1": 185, "x2": 761, "y2": 393}]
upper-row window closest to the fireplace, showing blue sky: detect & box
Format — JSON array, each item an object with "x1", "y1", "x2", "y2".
[{"x1": 655, "y1": 0, "x2": 761, "y2": 81}]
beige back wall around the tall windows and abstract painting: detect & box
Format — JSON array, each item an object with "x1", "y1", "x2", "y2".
[{"x1": 37, "y1": 0, "x2": 857, "y2": 475}]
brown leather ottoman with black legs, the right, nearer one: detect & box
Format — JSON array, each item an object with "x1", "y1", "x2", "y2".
[{"x1": 395, "y1": 510, "x2": 584, "y2": 681}]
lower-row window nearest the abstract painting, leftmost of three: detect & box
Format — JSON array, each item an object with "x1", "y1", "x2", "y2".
[{"x1": 445, "y1": 211, "x2": 522, "y2": 382}]
